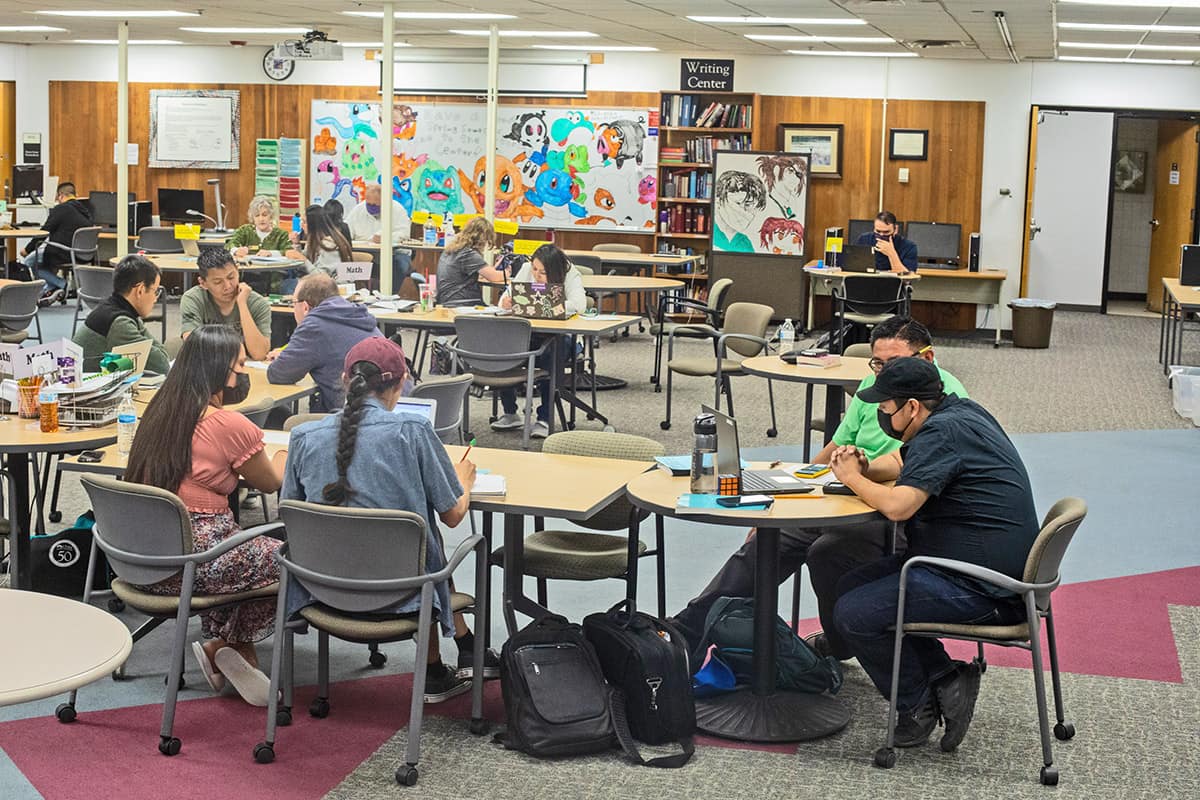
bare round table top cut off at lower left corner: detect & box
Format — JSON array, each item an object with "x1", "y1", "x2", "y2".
[{"x1": 0, "y1": 589, "x2": 133, "y2": 705}]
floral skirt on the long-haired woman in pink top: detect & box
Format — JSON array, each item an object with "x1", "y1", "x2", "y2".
[{"x1": 143, "y1": 511, "x2": 283, "y2": 643}]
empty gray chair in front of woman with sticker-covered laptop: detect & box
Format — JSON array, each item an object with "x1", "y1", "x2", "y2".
[{"x1": 450, "y1": 315, "x2": 553, "y2": 450}]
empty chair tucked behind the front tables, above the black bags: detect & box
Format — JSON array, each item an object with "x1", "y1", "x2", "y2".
[{"x1": 492, "y1": 431, "x2": 666, "y2": 618}]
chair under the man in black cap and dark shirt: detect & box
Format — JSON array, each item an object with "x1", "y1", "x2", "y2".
[{"x1": 875, "y1": 498, "x2": 1087, "y2": 786}]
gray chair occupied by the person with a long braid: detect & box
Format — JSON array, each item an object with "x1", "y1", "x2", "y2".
[{"x1": 254, "y1": 500, "x2": 487, "y2": 786}]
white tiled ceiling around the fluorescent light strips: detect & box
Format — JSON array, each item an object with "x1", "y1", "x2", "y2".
[{"x1": 0, "y1": 0, "x2": 1200, "y2": 61}]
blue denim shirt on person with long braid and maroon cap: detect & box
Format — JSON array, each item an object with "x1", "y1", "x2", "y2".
[{"x1": 280, "y1": 399, "x2": 463, "y2": 636}]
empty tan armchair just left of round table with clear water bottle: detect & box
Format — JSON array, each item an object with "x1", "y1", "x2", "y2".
[{"x1": 660, "y1": 302, "x2": 778, "y2": 437}]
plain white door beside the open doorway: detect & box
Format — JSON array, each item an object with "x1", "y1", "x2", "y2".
[{"x1": 1026, "y1": 110, "x2": 1114, "y2": 308}]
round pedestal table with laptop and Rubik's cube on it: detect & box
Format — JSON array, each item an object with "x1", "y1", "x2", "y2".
[{"x1": 625, "y1": 469, "x2": 880, "y2": 741}]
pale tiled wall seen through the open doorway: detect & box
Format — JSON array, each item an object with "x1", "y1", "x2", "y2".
[{"x1": 1108, "y1": 119, "x2": 1158, "y2": 294}]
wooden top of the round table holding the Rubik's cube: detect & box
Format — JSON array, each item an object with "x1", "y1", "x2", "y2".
[{"x1": 625, "y1": 463, "x2": 880, "y2": 528}]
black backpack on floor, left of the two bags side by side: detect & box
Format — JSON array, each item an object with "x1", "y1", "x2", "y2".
[{"x1": 494, "y1": 614, "x2": 616, "y2": 758}]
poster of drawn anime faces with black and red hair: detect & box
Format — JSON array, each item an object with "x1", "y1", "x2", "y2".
[{"x1": 713, "y1": 150, "x2": 809, "y2": 257}]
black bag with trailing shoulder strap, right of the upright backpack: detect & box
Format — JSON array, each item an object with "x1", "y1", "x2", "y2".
[{"x1": 583, "y1": 601, "x2": 696, "y2": 769}]
